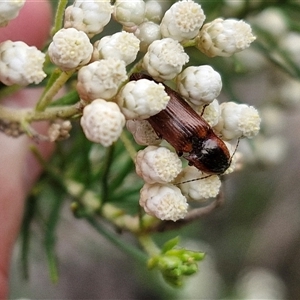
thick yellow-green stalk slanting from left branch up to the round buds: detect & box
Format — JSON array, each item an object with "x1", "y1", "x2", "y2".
[{"x1": 35, "y1": 70, "x2": 75, "y2": 111}]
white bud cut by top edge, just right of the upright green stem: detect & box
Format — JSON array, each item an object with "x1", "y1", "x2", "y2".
[{"x1": 64, "y1": 0, "x2": 113, "y2": 37}]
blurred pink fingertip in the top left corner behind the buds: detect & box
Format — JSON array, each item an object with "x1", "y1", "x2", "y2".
[{"x1": 0, "y1": 0, "x2": 52, "y2": 48}]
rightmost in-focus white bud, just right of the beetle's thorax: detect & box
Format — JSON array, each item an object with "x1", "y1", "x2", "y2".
[{"x1": 214, "y1": 102, "x2": 261, "y2": 140}]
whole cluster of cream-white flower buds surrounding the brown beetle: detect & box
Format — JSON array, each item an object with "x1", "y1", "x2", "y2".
[{"x1": 0, "y1": 0, "x2": 260, "y2": 221}]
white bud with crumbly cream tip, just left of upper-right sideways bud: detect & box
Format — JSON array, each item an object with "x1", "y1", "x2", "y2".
[{"x1": 160, "y1": 0, "x2": 205, "y2": 42}]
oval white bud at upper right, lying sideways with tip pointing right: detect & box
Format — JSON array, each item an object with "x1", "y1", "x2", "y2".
[{"x1": 196, "y1": 18, "x2": 255, "y2": 57}]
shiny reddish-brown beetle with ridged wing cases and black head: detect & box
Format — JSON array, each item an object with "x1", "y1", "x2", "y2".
[{"x1": 130, "y1": 73, "x2": 231, "y2": 175}]
